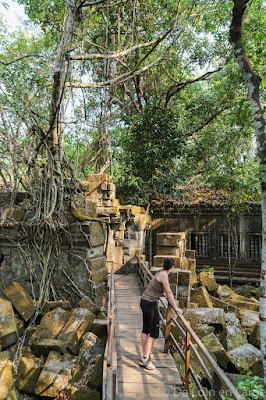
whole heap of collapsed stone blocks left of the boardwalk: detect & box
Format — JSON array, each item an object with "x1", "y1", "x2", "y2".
[{"x1": 0, "y1": 283, "x2": 106, "y2": 400}]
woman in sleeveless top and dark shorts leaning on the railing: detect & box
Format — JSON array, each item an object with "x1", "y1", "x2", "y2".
[{"x1": 140, "y1": 258, "x2": 183, "y2": 369}]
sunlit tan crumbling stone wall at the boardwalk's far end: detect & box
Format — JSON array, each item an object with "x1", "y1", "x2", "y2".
[{"x1": 79, "y1": 174, "x2": 151, "y2": 272}]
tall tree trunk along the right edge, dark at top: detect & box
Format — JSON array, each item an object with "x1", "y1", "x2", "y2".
[{"x1": 229, "y1": 0, "x2": 266, "y2": 384}]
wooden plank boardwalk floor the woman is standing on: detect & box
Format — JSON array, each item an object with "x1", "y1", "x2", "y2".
[{"x1": 115, "y1": 274, "x2": 189, "y2": 400}]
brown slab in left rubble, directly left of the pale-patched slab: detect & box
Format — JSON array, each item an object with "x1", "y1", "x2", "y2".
[{"x1": 33, "y1": 308, "x2": 69, "y2": 343}]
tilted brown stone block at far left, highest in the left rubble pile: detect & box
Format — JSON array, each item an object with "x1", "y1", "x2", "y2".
[{"x1": 4, "y1": 282, "x2": 35, "y2": 322}]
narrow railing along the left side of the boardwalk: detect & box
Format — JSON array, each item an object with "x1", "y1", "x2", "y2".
[{"x1": 102, "y1": 262, "x2": 117, "y2": 400}]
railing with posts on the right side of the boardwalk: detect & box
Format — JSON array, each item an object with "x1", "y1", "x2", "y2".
[{"x1": 137, "y1": 256, "x2": 243, "y2": 400}]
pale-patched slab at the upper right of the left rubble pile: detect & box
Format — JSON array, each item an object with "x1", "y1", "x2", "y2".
[{"x1": 57, "y1": 308, "x2": 95, "y2": 354}]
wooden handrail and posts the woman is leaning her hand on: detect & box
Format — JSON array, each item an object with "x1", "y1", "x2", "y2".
[{"x1": 137, "y1": 255, "x2": 243, "y2": 400}]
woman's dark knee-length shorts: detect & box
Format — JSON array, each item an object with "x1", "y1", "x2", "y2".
[{"x1": 140, "y1": 299, "x2": 160, "y2": 339}]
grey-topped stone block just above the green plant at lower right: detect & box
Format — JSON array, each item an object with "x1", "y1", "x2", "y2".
[{"x1": 228, "y1": 343, "x2": 262, "y2": 375}]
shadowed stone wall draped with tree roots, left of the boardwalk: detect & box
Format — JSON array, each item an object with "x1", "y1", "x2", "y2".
[{"x1": 0, "y1": 221, "x2": 108, "y2": 305}]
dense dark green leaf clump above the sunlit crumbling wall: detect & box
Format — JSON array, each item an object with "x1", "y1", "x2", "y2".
[{"x1": 113, "y1": 105, "x2": 185, "y2": 202}]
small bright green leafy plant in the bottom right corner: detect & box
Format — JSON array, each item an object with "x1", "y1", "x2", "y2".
[{"x1": 225, "y1": 371, "x2": 264, "y2": 400}]
